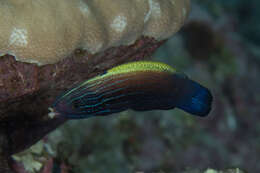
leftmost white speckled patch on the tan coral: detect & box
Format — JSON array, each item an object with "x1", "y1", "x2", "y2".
[{"x1": 9, "y1": 28, "x2": 28, "y2": 47}]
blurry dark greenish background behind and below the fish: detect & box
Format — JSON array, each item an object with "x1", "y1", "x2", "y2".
[{"x1": 45, "y1": 0, "x2": 260, "y2": 173}]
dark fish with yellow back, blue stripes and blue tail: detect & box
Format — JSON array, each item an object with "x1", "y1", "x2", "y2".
[{"x1": 51, "y1": 61, "x2": 213, "y2": 119}]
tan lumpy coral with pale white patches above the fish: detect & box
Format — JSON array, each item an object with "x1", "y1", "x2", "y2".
[{"x1": 0, "y1": 0, "x2": 190, "y2": 65}]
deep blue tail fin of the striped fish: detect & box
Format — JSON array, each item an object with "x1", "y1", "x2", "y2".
[{"x1": 176, "y1": 79, "x2": 213, "y2": 117}]
